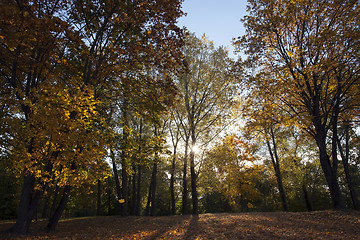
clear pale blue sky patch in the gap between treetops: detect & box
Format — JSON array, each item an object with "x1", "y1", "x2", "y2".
[{"x1": 178, "y1": 0, "x2": 246, "y2": 58}]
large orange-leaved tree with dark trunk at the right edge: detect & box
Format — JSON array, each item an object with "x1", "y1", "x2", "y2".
[{"x1": 237, "y1": 0, "x2": 360, "y2": 209}]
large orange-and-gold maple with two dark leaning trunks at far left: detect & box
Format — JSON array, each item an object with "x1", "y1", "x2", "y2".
[{"x1": 0, "y1": 0, "x2": 182, "y2": 233}]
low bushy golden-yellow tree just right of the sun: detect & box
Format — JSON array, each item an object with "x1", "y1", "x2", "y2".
[{"x1": 205, "y1": 135, "x2": 262, "y2": 212}]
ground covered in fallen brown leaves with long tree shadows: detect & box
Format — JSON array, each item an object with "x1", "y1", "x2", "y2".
[{"x1": 0, "y1": 211, "x2": 360, "y2": 240}]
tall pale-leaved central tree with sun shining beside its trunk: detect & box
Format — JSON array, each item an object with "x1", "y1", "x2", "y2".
[{"x1": 177, "y1": 34, "x2": 237, "y2": 214}]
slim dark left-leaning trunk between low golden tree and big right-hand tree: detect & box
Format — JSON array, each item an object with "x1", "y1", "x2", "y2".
[{"x1": 266, "y1": 128, "x2": 289, "y2": 211}]
